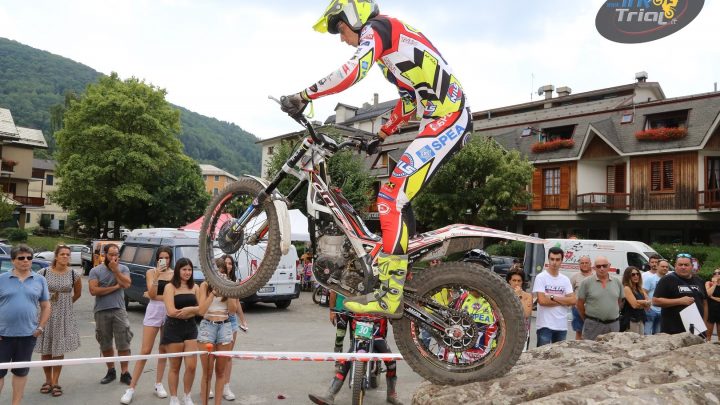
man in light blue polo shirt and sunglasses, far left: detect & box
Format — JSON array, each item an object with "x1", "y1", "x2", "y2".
[{"x1": 0, "y1": 245, "x2": 50, "y2": 405}]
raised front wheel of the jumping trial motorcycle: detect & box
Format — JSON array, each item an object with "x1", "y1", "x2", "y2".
[{"x1": 199, "y1": 177, "x2": 281, "y2": 298}]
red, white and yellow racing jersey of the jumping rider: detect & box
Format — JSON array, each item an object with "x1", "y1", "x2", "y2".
[{"x1": 303, "y1": 15, "x2": 468, "y2": 135}]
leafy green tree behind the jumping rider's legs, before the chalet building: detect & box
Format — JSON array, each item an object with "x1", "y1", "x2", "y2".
[{"x1": 412, "y1": 136, "x2": 533, "y2": 228}]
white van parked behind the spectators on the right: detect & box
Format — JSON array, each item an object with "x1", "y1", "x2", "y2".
[{"x1": 545, "y1": 239, "x2": 657, "y2": 277}]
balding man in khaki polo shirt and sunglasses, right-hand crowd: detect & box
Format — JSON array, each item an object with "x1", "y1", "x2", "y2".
[{"x1": 577, "y1": 256, "x2": 623, "y2": 340}]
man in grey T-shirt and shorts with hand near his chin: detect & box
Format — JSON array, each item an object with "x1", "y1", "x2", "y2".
[{"x1": 88, "y1": 243, "x2": 133, "y2": 385}]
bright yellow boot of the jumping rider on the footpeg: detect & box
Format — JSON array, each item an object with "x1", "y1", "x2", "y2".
[{"x1": 344, "y1": 253, "x2": 408, "y2": 319}]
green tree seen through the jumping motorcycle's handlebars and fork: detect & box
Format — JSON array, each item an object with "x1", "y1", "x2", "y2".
[{"x1": 267, "y1": 133, "x2": 375, "y2": 213}]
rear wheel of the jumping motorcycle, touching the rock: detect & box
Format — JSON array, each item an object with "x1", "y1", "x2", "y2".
[{"x1": 392, "y1": 262, "x2": 528, "y2": 385}]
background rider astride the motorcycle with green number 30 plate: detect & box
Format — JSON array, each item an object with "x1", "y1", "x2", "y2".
[{"x1": 308, "y1": 307, "x2": 402, "y2": 405}]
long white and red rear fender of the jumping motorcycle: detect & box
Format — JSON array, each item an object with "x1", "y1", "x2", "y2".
[{"x1": 408, "y1": 224, "x2": 545, "y2": 262}]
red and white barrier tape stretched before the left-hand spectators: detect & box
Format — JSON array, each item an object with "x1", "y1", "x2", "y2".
[{"x1": 0, "y1": 351, "x2": 403, "y2": 370}]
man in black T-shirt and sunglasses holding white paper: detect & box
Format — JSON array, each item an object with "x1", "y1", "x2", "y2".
[{"x1": 653, "y1": 253, "x2": 707, "y2": 334}]
